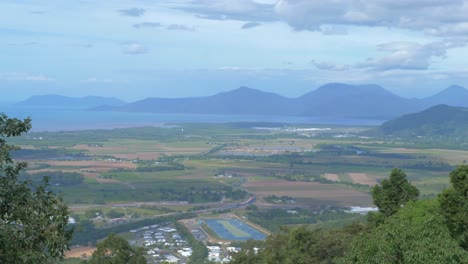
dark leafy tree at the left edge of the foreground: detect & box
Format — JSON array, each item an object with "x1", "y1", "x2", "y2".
[{"x1": 0, "y1": 114, "x2": 72, "y2": 263}]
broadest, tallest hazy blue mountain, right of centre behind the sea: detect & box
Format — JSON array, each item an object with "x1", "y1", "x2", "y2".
[{"x1": 298, "y1": 83, "x2": 422, "y2": 118}]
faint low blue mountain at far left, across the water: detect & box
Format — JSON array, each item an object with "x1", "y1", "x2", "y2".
[{"x1": 17, "y1": 95, "x2": 125, "y2": 109}]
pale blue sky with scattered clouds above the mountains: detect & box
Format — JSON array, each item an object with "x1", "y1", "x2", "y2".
[{"x1": 0, "y1": 0, "x2": 468, "y2": 102}]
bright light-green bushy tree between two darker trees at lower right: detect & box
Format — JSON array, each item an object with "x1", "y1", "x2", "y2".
[{"x1": 339, "y1": 200, "x2": 468, "y2": 264}]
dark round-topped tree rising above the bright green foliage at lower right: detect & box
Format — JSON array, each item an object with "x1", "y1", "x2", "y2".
[{"x1": 369, "y1": 169, "x2": 419, "y2": 223}]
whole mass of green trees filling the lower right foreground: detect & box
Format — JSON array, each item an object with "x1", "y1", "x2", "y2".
[{"x1": 232, "y1": 166, "x2": 468, "y2": 264}]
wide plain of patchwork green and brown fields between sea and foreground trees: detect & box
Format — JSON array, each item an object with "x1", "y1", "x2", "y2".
[{"x1": 8, "y1": 123, "x2": 468, "y2": 258}]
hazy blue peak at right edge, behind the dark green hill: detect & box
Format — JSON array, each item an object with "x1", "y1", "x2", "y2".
[{"x1": 421, "y1": 85, "x2": 468, "y2": 107}]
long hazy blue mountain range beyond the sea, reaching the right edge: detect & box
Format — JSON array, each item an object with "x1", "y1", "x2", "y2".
[{"x1": 22, "y1": 83, "x2": 468, "y2": 120}]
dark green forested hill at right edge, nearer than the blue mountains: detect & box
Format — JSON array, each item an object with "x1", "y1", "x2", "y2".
[{"x1": 372, "y1": 105, "x2": 468, "y2": 136}]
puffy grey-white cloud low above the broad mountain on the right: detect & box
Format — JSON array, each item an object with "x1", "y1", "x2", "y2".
[{"x1": 357, "y1": 42, "x2": 449, "y2": 71}]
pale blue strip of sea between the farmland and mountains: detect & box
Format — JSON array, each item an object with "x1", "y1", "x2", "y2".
[{"x1": 0, "y1": 103, "x2": 385, "y2": 132}]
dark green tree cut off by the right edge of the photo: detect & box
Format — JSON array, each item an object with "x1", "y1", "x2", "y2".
[{"x1": 438, "y1": 165, "x2": 468, "y2": 250}]
